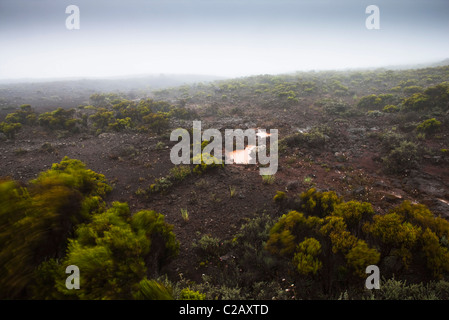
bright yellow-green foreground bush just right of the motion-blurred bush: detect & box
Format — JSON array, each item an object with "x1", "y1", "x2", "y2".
[{"x1": 57, "y1": 202, "x2": 179, "y2": 299}]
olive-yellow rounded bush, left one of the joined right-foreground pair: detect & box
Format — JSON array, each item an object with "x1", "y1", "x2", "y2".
[{"x1": 265, "y1": 188, "x2": 380, "y2": 298}]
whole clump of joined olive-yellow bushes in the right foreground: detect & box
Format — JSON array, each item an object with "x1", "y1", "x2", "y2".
[{"x1": 265, "y1": 189, "x2": 449, "y2": 294}]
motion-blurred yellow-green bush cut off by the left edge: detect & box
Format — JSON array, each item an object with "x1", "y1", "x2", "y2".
[{"x1": 0, "y1": 157, "x2": 111, "y2": 299}]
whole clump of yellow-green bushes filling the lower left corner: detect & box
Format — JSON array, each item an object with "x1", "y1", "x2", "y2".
[{"x1": 0, "y1": 157, "x2": 179, "y2": 299}]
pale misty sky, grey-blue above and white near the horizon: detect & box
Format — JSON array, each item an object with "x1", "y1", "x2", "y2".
[{"x1": 0, "y1": 0, "x2": 449, "y2": 79}]
